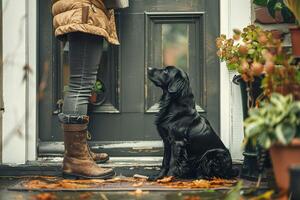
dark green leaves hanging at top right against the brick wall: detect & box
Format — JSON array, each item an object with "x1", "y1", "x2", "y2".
[{"x1": 253, "y1": 0, "x2": 295, "y2": 23}]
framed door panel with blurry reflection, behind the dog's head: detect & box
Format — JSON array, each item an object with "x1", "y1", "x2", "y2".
[{"x1": 145, "y1": 12, "x2": 206, "y2": 113}]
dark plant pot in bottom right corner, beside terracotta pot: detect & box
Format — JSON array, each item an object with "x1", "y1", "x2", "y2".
[{"x1": 289, "y1": 165, "x2": 300, "y2": 200}]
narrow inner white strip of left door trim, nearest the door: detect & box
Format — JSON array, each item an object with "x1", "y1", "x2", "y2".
[{"x1": 26, "y1": 0, "x2": 38, "y2": 161}]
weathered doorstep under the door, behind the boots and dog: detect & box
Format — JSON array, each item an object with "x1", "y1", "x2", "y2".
[{"x1": 0, "y1": 157, "x2": 241, "y2": 177}]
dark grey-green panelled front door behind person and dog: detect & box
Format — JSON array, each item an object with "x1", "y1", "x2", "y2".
[{"x1": 38, "y1": 0, "x2": 220, "y2": 156}]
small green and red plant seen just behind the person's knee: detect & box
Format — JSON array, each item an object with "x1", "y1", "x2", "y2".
[{"x1": 89, "y1": 79, "x2": 106, "y2": 105}]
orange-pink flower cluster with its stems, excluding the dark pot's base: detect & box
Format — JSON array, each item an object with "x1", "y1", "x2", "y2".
[{"x1": 216, "y1": 25, "x2": 283, "y2": 109}]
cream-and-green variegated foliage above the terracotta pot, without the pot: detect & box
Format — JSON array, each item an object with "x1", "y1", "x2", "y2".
[{"x1": 244, "y1": 93, "x2": 300, "y2": 149}]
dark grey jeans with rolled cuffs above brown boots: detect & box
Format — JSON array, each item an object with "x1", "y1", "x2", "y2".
[{"x1": 58, "y1": 32, "x2": 103, "y2": 124}]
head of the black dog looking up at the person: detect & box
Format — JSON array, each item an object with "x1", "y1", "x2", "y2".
[{"x1": 148, "y1": 66, "x2": 189, "y2": 94}]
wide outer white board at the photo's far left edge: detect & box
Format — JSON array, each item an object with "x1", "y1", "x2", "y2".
[{"x1": 2, "y1": 0, "x2": 26, "y2": 163}]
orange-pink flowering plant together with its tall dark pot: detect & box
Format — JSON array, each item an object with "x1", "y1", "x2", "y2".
[{"x1": 216, "y1": 25, "x2": 282, "y2": 180}]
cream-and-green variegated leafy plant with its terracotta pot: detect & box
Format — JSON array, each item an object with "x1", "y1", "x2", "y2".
[{"x1": 244, "y1": 93, "x2": 300, "y2": 191}]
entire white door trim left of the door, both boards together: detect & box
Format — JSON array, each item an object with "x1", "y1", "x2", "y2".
[{"x1": 1, "y1": 0, "x2": 37, "y2": 164}]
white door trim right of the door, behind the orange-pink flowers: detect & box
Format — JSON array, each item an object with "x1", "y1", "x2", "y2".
[{"x1": 220, "y1": 0, "x2": 251, "y2": 160}]
